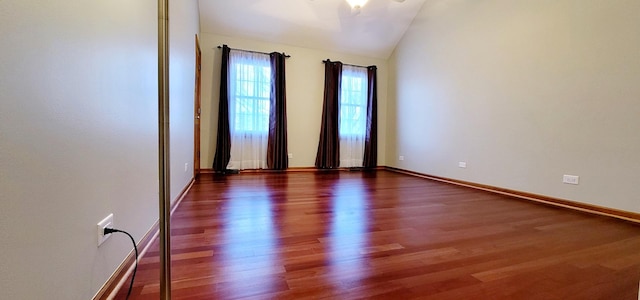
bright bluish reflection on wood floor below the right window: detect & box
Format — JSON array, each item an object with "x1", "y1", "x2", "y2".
[{"x1": 329, "y1": 180, "x2": 369, "y2": 289}]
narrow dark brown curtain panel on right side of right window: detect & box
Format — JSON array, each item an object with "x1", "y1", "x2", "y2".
[{"x1": 362, "y1": 66, "x2": 378, "y2": 168}]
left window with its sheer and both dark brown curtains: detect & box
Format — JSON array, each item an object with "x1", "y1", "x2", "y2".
[{"x1": 215, "y1": 47, "x2": 288, "y2": 172}]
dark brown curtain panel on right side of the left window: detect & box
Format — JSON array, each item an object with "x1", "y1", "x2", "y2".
[{"x1": 267, "y1": 52, "x2": 289, "y2": 170}]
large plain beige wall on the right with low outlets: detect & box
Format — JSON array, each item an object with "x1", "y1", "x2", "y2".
[{"x1": 388, "y1": 0, "x2": 640, "y2": 212}]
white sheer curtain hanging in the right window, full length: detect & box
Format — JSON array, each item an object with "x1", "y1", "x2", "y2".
[{"x1": 338, "y1": 65, "x2": 367, "y2": 168}]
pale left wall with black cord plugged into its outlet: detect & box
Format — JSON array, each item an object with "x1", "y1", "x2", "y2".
[{"x1": 0, "y1": 0, "x2": 198, "y2": 299}]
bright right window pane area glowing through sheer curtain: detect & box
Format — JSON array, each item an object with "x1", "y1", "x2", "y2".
[{"x1": 339, "y1": 65, "x2": 367, "y2": 138}]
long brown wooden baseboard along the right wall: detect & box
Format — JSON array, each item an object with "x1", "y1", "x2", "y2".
[{"x1": 384, "y1": 167, "x2": 640, "y2": 223}]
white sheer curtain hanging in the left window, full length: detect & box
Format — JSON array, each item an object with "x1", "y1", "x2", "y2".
[{"x1": 227, "y1": 50, "x2": 271, "y2": 170}]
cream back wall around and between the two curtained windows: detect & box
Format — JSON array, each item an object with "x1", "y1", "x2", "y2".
[{"x1": 200, "y1": 33, "x2": 388, "y2": 169}]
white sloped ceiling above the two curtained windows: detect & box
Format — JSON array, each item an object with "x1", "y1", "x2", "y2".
[{"x1": 199, "y1": 0, "x2": 426, "y2": 59}]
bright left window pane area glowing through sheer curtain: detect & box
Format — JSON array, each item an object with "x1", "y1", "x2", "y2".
[{"x1": 229, "y1": 53, "x2": 271, "y2": 134}]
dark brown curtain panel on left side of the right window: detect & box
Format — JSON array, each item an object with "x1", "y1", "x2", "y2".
[{"x1": 316, "y1": 60, "x2": 342, "y2": 169}]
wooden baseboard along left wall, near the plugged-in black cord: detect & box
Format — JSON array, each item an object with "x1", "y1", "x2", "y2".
[{"x1": 93, "y1": 178, "x2": 195, "y2": 300}]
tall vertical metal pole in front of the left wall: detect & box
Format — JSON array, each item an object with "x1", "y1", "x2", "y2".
[{"x1": 158, "y1": 0, "x2": 171, "y2": 300}]
